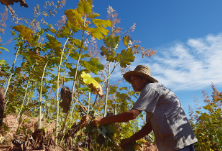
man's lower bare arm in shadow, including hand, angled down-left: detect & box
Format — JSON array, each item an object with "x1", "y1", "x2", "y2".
[{"x1": 120, "y1": 122, "x2": 152, "y2": 148}]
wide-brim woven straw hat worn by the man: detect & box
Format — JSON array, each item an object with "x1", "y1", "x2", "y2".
[{"x1": 123, "y1": 65, "x2": 158, "y2": 83}]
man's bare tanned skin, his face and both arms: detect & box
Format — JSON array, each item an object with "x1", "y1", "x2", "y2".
[{"x1": 91, "y1": 75, "x2": 152, "y2": 149}]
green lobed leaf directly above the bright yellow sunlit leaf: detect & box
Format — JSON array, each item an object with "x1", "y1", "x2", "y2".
[{"x1": 81, "y1": 58, "x2": 104, "y2": 74}]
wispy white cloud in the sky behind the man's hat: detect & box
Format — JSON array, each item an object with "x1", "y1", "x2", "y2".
[{"x1": 126, "y1": 33, "x2": 222, "y2": 91}]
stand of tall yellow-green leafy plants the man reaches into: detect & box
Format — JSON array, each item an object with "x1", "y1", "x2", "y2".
[{"x1": 0, "y1": 0, "x2": 155, "y2": 150}]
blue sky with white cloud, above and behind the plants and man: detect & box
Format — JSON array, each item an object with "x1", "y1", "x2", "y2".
[{"x1": 0, "y1": 0, "x2": 222, "y2": 118}]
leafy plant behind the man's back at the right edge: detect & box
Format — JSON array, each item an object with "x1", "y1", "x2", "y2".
[{"x1": 190, "y1": 84, "x2": 222, "y2": 151}]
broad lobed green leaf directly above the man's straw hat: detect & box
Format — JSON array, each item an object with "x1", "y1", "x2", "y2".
[{"x1": 116, "y1": 48, "x2": 135, "y2": 68}]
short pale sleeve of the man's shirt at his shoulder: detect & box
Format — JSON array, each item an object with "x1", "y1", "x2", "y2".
[{"x1": 133, "y1": 85, "x2": 160, "y2": 113}]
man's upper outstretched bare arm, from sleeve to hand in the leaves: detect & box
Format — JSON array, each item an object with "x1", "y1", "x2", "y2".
[{"x1": 91, "y1": 109, "x2": 141, "y2": 126}]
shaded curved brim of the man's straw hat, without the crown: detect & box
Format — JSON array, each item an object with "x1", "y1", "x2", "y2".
[{"x1": 123, "y1": 71, "x2": 158, "y2": 83}]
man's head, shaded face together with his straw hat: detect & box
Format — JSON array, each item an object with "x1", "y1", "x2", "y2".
[{"x1": 123, "y1": 65, "x2": 158, "y2": 92}]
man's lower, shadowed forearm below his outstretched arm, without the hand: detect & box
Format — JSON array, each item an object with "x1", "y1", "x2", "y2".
[{"x1": 130, "y1": 123, "x2": 152, "y2": 142}]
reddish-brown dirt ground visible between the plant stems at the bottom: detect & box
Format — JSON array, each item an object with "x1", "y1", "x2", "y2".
[{"x1": 0, "y1": 114, "x2": 158, "y2": 151}]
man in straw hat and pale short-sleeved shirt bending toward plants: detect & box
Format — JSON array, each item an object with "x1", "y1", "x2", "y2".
[{"x1": 92, "y1": 65, "x2": 197, "y2": 151}]
